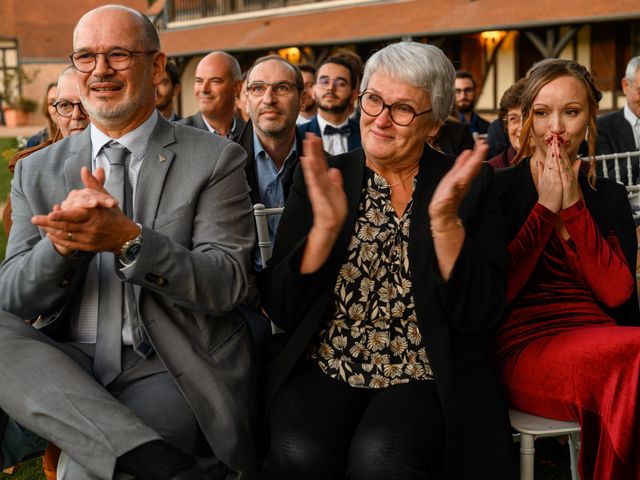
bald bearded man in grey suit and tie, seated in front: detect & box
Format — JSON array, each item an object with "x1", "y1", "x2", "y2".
[{"x1": 0, "y1": 6, "x2": 256, "y2": 480}]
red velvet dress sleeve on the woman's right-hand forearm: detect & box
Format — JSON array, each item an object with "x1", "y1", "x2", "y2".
[{"x1": 560, "y1": 200, "x2": 634, "y2": 308}]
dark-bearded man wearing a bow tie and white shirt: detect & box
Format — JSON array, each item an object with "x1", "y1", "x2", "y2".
[{"x1": 298, "y1": 57, "x2": 360, "y2": 155}]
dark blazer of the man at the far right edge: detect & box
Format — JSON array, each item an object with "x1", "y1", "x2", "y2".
[{"x1": 596, "y1": 109, "x2": 640, "y2": 185}]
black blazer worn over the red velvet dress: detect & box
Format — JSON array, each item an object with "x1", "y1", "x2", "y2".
[{"x1": 495, "y1": 158, "x2": 640, "y2": 325}]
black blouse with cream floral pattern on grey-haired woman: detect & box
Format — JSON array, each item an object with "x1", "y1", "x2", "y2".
[{"x1": 307, "y1": 168, "x2": 433, "y2": 388}]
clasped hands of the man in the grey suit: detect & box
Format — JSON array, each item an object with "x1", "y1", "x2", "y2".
[{"x1": 31, "y1": 167, "x2": 139, "y2": 256}]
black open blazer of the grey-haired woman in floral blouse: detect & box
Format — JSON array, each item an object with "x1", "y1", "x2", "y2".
[{"x1": 259, "y1": 147, "x2": 513, "y2": 480}]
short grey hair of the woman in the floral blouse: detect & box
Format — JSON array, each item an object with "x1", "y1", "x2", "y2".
[{"x1": 360, "y1": 42, "x2": 456, "y2": 123}]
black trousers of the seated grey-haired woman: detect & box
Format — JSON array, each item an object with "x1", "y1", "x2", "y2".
[{"x1": 259, "y1": 362, "x2": 445, "y2": 480}]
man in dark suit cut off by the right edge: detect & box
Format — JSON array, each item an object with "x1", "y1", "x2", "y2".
[{"x1": 596, "y1": 56, "x2": 640, "y2": 185}]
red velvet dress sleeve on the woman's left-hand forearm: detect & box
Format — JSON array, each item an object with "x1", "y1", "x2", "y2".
[{"x1": 507, "y1": 203, "x2": 558, "y2": 305}]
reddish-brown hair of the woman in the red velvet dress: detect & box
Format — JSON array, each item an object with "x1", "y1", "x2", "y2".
[{"x1": 513, "y1": 58, "x2": 602, "y2": 187}]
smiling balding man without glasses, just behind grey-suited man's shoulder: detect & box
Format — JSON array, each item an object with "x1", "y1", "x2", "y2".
[{"x1": 180, "y1": 52, "x2": 244, "y2": 141}]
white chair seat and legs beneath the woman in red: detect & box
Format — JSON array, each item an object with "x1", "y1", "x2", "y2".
[{"x1": 509, "y1": 408, "x2": 580, "y2": 480}]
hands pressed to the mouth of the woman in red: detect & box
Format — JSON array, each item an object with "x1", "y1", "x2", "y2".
[{"x1": 536, "y1": 135, "x2": 580, "y2": 213}]
